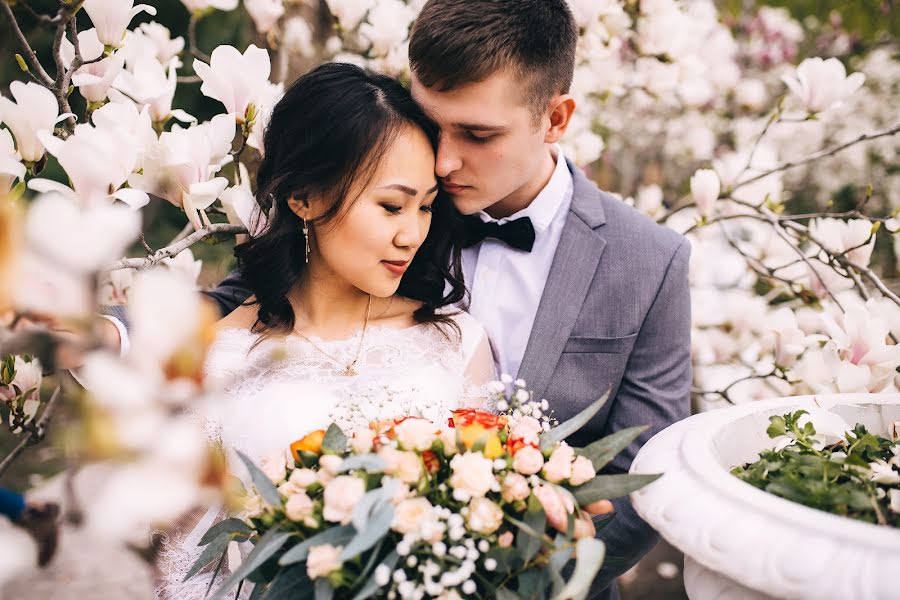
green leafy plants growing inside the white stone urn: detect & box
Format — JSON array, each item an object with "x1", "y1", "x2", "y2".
[{"x1": 731, "y1": 410, "x2": 900, "y2": 527}]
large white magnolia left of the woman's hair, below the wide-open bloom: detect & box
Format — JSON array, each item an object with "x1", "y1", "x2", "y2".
[{"x1": 128, "y1": 115, "x2": 234, "y2": 229}]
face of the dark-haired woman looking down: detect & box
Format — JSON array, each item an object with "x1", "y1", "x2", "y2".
[{"x1": 309, "y1": 127, "x2": 438, "y2": 297}]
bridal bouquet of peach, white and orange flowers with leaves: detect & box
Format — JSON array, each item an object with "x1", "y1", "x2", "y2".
[{"x1": 187, "y1": 380, "x2": 657, "y2": 600}]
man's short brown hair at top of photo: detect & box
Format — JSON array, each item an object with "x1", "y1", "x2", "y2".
[{"x1": 409, "y1": 0, "x2": 578, "y2": 117}]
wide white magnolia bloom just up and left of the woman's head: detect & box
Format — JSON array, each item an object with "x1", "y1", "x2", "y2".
[{"x1": 194, "y1": 44, "x2": 271, "y2": 123}]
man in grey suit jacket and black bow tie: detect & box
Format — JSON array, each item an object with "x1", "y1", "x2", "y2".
[{"x1": 103, "y1": 0, "x2": 691, "y2": 598}]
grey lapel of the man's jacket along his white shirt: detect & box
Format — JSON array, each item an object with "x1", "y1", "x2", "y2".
[{"x1": 518, "y1": 163, "x2": 606, "y2": 398}]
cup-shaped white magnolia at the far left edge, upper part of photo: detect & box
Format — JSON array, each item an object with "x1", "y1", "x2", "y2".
[{"x1": 0, "y1": 81, "x2": 71, "y2": 162}]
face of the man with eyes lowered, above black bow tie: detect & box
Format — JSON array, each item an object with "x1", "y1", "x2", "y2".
[{"x1": 412, "y1": 71, "x2": 550, "y2": 217}]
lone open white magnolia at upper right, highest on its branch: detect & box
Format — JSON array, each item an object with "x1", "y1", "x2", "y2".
[{"x1": 783, "y1": 57, "x2": 866, "y2": 113}]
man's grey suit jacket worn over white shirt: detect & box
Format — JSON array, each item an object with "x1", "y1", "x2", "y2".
[{"x1": 110, "y1": 159, "x2": 691, "y2": 598}]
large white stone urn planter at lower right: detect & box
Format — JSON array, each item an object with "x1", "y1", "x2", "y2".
[{"x1": 631, "y1": 393, "x2": 900, "y2": 600}]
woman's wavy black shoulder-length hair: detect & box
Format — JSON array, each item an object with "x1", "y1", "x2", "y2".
[{"x1": 234, "y1": 63, "x2": 465, "y2": 335}]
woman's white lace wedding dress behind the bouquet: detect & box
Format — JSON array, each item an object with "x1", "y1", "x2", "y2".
[{"x1": 157, "y1": 313, "x2": 494, "y2": 600}]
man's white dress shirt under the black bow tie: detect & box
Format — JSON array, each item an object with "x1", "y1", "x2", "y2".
[{"x1": 462, "y1": 146, "x2": 573, "y2": 377}]
